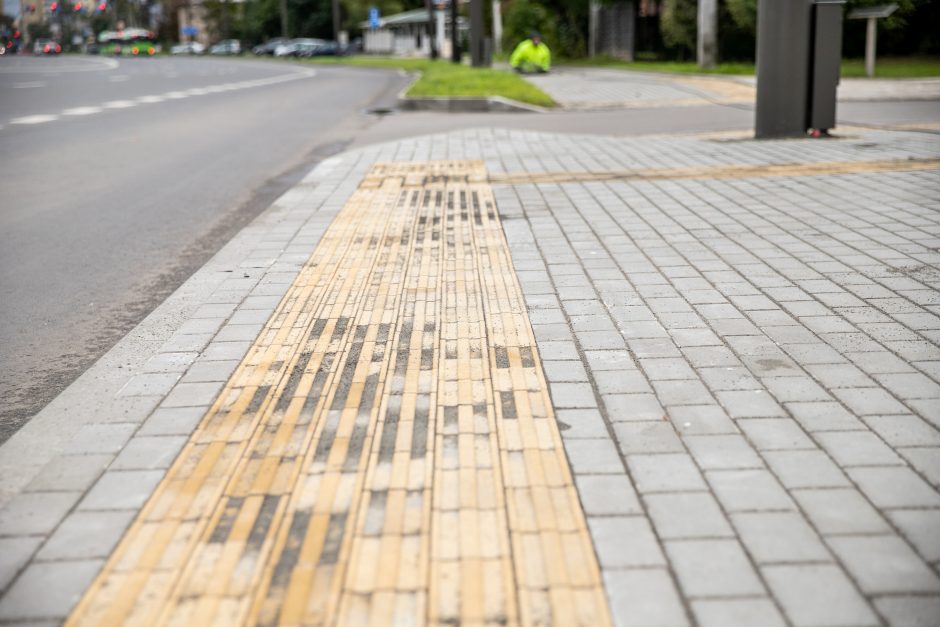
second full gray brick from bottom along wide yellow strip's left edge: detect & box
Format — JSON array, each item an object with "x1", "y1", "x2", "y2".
[{"x1": 36, "y1": 510, "x2": 136, "y2": 561}]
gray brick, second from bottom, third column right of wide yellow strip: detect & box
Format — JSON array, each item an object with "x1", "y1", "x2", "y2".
[{"x1": 731, "y1": 512, "x2": 831, "y2": 564}]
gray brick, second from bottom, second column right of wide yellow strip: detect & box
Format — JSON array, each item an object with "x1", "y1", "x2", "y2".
[{"x1": 665, "y1": 540, "x2": 764, "y2": 598}]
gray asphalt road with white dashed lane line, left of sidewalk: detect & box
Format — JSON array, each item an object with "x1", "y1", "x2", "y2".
[{"x1": 0, "y1": 56, "x2": 404, "y2": 442}]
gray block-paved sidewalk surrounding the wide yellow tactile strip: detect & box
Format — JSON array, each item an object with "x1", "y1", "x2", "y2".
[{"x1": 0, "y1": 125, "x2": 940, "y2": 626}]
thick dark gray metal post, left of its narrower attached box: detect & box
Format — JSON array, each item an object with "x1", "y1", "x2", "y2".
[{"x1": 754, "y1": 0, "x2": 813, "y2": 138}]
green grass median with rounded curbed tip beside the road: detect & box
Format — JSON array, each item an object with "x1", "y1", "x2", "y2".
[{"x1": 302, "y1": 56, "x2": 555, "y2": 107}]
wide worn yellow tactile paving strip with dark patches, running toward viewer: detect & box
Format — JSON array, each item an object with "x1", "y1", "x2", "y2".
[{"x1": 68, "y1": 162, "x2": 610, "y2": 627}]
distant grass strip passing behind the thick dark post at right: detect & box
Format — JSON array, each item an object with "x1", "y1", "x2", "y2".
[{"x1": 570, "y1": 57, "x2": 940, "y2": 78}]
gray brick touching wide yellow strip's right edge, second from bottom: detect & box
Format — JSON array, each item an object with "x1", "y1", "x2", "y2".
[{"x1": 588, "y1": 516, "x2": 666, "y2": 569}]
